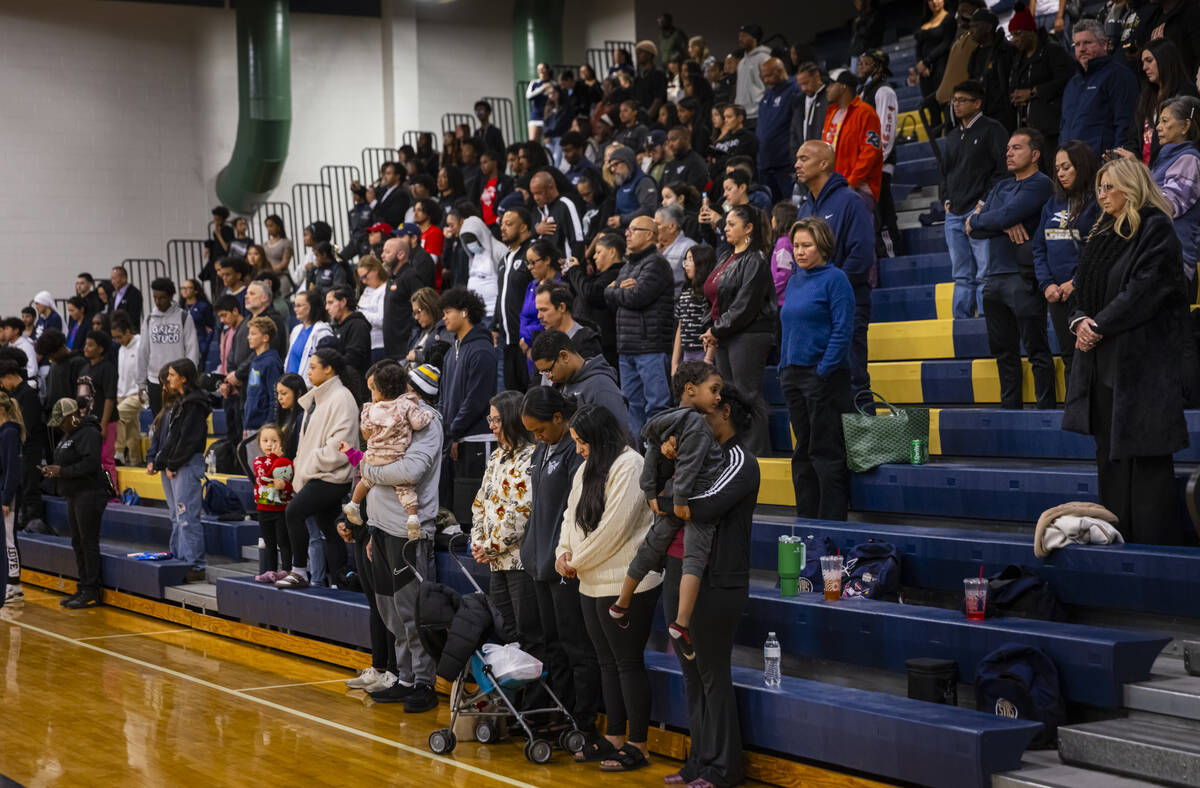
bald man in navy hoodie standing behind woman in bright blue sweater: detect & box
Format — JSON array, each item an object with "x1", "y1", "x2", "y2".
[{"x1": 792, "y1": 139, "x2": 876, "y2": 391}]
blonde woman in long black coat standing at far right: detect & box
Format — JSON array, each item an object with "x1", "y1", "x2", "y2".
[{"x1": 1063, "y1": 158, "x2": 1194, "y2": 545}]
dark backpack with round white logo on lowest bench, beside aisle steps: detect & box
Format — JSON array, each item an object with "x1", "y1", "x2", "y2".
[{"x1": 976, "y1": 643, "x2": 1067, "y2": 747}]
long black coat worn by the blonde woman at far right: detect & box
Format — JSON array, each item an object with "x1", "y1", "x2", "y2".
[{"x1": 1062, "y1": 206, "x2": 1195, "y2": 459}]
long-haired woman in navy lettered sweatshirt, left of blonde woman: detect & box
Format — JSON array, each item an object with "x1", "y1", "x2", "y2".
[{"x1": 1033, "y1": 139, "x2": 1100, "y2": 386}]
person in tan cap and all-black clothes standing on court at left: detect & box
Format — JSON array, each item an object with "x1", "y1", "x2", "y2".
[{"x1": 42, "y1": 397, "x2": 113, "y2": 609}]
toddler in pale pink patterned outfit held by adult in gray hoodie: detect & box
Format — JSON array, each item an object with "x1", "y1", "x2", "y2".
[{"x1": 337, "y1": 363, "x2": 433, "y2": 539}]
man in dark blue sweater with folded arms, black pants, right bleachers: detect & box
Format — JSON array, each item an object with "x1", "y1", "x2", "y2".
[{"x1": 966, "y1": 128, "x2": 1055, "y2": 410}]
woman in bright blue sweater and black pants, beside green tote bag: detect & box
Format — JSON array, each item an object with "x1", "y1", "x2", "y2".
[{"x1": 779, "y1": 216, "x2": 854, "y2": 521}]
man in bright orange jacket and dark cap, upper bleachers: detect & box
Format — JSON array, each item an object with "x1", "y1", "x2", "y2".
[{"x1": 822, "y1": 71, "x2": 883, "y2": 212}]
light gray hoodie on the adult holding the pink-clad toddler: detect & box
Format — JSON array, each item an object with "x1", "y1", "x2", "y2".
[{"x1": 359, "y1": 403, "x2": 442, "y2": 539}]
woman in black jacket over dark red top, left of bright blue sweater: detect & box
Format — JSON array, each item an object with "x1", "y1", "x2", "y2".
[{"x1": 701, "y1": 205, "x2": 779, "y2": 455}]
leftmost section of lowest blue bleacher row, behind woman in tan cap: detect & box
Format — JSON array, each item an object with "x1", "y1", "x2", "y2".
[{"x1": 17, "y1": 533, "x2": 191, "y2": 600}]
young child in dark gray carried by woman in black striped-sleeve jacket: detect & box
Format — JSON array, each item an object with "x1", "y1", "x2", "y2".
[{"x1": 608, "y1": 361, "x2": 724, "y2": 660}]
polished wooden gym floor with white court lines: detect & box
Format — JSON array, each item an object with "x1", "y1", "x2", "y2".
[{"x1": 0, "y1": 583, "x2": 782, "y2": 788}]
